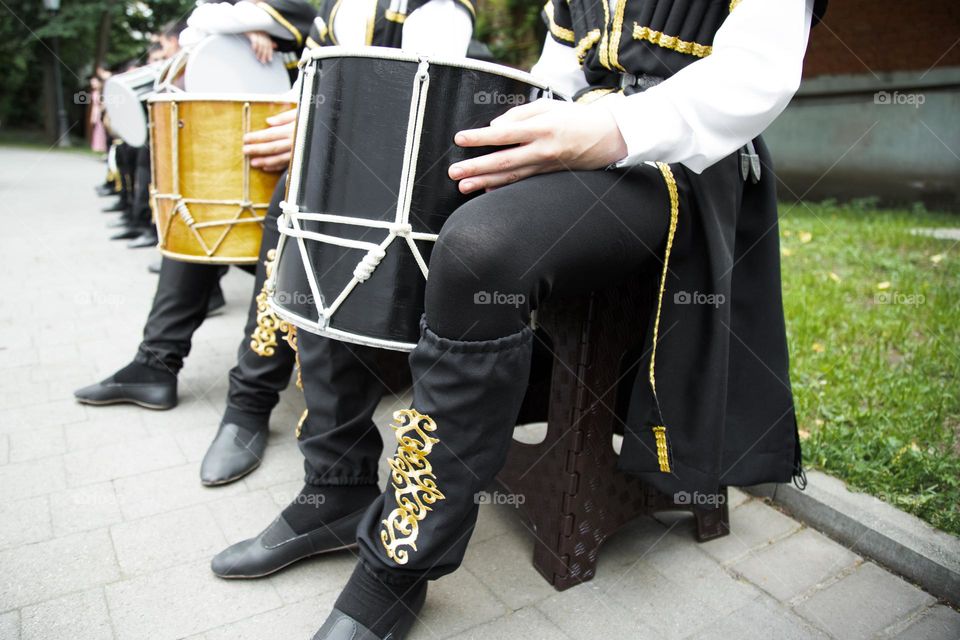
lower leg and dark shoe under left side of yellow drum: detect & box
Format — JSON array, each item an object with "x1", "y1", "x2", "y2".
[{"x1": 74, "y1": 258, "x2": 220, "y2": 409}]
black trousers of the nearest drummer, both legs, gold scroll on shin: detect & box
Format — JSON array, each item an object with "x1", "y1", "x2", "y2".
[{"x1": 282, "y1": 165, "x2": 670, "y2": 580}]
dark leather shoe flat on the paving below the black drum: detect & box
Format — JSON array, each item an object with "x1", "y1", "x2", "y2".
[{"x1": 210, "y1": 505, "x2": 369, "y2": 579}]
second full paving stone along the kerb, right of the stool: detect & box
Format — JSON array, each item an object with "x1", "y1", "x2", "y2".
[{"x1": 732, "y1": 529, "x2": 860, "y2": 601}]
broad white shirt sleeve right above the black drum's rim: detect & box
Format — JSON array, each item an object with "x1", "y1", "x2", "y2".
[{"x1": 400, "y1": 0, "x2": 473, "y2": 58}]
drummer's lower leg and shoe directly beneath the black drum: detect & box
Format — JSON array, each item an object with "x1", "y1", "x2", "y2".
[{"x1": 211, "y1": 331, "x2": 383, "y2": 578}]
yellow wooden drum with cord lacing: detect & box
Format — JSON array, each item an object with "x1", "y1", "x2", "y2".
[{"x1": 149, "y1": 93, "x2": 295, "y2": 264}]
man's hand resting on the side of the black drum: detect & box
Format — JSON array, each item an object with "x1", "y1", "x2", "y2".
[{"x1": 448, "y1": 99, "x2": 627, "y2": 193}]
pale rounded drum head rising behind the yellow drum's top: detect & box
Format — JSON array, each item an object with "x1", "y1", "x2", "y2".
[{"x1": 184, "y1": 35, "x2": 290, "y2": 93}]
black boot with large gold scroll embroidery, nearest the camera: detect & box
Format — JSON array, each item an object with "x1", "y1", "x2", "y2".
[{"x1": 314, "y1": 323, "x2": 533, "y2": 640}]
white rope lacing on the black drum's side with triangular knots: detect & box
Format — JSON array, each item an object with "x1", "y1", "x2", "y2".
[{"x1": 270, "y1": 58, "x2": 437, "y2": 325}]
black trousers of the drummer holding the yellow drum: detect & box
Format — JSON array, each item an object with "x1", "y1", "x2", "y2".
[{"x1": 135, "y1": 179, "x2": 294, "y2": 414}]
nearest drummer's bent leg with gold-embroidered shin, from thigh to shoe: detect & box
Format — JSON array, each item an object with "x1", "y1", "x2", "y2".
[{"x1": 316, "y1": 166, "x2": 669, "y2": 638}]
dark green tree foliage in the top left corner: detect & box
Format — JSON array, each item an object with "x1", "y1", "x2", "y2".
[{"x1": 0, "y1": 0, "x2": 194, "y2": 133}]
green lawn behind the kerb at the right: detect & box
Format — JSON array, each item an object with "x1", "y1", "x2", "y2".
[{"x1": 780, "y1": 202, "x2": 960, "y2": 535}]
